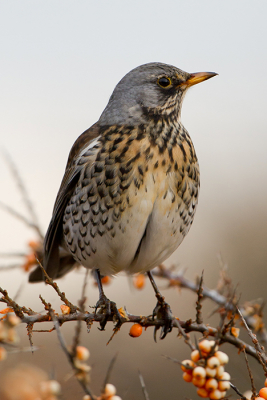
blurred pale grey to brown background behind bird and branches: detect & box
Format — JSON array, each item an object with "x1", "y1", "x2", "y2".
[{"x1": 0, "y1": 0, "x2": 267, "y2": 400}]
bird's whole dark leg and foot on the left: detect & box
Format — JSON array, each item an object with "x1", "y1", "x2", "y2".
[{"x1": 95, "y1": 269, "x2": 122, "y2": 331}]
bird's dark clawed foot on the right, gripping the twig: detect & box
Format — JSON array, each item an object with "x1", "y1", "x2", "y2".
[{"x1": 152, "y1": 295, "x2": 173, "y2": 342}]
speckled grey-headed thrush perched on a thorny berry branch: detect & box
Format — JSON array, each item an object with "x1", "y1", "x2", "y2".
[{"x1": 29, "y1": 62, "x2": 217, "y2": 338}]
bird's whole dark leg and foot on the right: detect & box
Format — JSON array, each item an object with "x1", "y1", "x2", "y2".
[{"x1": 147, "y1": 271, "x2": 172, "y2": 342}]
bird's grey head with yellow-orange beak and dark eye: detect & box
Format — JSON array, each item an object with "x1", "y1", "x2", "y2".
[{"x1": 99, "y1": 63, "x2": 217, "y2": 125}]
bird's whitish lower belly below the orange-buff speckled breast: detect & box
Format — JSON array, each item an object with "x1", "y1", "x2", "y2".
[{"x1": 62, "y1": 170, "x2": 197, "y2": 275}]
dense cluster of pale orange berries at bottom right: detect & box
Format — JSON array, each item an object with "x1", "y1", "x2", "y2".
[{"x1": 181, "y1": 339, "x2": 230, "y2": 400}]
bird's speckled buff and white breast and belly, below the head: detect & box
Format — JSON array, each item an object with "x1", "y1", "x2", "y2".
[{"x1": 63, "y1": 123, "x2": 199, "y2": 275}]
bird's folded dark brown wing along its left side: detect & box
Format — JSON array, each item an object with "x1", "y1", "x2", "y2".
[{"x1": 29, "y1": 123, "x2": 99, "y2": 282}]
